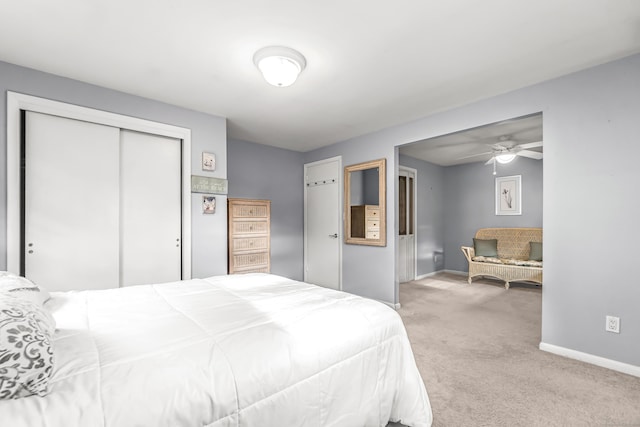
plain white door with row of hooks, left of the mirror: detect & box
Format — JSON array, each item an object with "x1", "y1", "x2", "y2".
[{"x1": 304, "y1": 157, "x2": 342, "y2": 290}]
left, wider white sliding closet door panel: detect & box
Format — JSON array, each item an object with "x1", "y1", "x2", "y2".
[{"x1": 23, "y1": 112, "x2": 120, "y2": 291}]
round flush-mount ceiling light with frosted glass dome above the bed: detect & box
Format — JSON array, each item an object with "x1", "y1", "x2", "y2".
[{"x1": 253, "y1": 46, "x2": 307, "y2": 87}]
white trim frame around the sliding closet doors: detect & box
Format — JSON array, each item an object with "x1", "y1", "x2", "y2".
[{"x1": 7, "y1": 91, "x2": 191, "y2": 280}]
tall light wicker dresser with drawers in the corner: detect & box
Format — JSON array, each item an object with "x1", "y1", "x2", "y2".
[{"x1": 228, "y1": 198, "x2": 271, "y2": 274}]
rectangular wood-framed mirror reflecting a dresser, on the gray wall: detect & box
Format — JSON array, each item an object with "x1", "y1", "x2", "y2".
[{"x1": 344, "y1": 159, "x2": 387, "y2": 246}]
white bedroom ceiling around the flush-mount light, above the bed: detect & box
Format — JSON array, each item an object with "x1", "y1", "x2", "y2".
[{"x1": 0, "y1": 0, "x2": 640, "y2": 151}]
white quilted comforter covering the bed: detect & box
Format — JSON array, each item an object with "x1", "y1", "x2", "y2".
[{"x1": 0, "y1": 274, "x2": 432, "y2": 427}]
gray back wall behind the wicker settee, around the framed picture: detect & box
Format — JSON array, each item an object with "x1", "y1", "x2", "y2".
[{"x1": 444, "y1": 157, "x2": 543, "y2": 271}]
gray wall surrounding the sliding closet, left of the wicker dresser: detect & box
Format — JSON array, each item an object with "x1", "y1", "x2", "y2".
[{"x1": 0, "y1": 62, "x2": 227, "y2": 277}]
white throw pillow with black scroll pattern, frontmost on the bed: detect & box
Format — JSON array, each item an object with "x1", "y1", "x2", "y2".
[{"x1": 0, "y1": 292, "x2": 55, "y2": 399}]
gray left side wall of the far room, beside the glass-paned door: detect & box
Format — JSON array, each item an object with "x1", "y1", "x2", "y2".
[{"x1": 400, "y1": 156, "x2": 444, "y2": 277}]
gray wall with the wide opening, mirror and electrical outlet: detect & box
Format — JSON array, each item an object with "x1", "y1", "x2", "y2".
[{"x1": 305, "y1": 55, "x2": 640, "y2": 366}]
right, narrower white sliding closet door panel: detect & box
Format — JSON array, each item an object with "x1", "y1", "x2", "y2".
[{"x1": 120, "y1": 130, "x2": 182, "y2": 286}]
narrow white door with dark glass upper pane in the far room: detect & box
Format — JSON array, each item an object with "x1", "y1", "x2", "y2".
[{"x1": 398, "y1": 166, "x2": 416, "y2": 283}]
